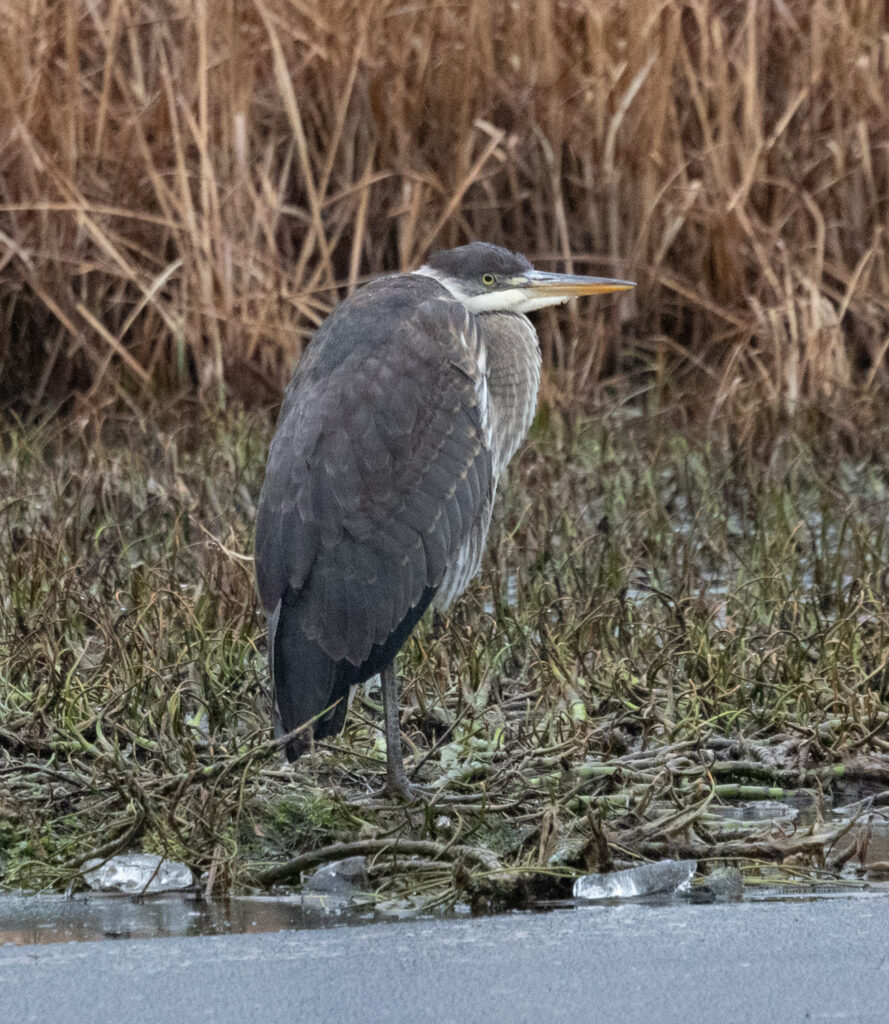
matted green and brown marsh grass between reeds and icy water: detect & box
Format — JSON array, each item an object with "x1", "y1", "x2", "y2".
[{"x1": 0, "y1": 409, "x2": 889, "y2": 907}]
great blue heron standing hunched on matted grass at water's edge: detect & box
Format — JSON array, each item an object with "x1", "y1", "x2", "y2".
[{"x1": 256, "y1": 242, "x2": 633, "y2": 796}]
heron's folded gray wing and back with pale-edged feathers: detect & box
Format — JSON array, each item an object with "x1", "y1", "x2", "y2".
[{"x1": 256, "y1": 279, "x2": 493, "y2": 665}]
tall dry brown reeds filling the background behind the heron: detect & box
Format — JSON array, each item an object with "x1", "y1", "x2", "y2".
[{"x1": 0, "y1": 0, "x2": 889, "y2": 416}]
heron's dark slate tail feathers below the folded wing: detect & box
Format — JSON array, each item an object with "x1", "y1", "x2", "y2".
[{"x1": 268, "y1": 601, "x2": 358, "y2": 761}]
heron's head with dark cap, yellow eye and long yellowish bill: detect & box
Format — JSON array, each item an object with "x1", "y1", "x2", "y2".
[{"x1": 416, "y1": 242, "x2": 636, "y2": 313}]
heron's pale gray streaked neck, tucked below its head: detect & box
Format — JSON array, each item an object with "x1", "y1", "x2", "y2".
[{"x1": 478, "y1": 312, "x2": 541, "y2": 476}]
